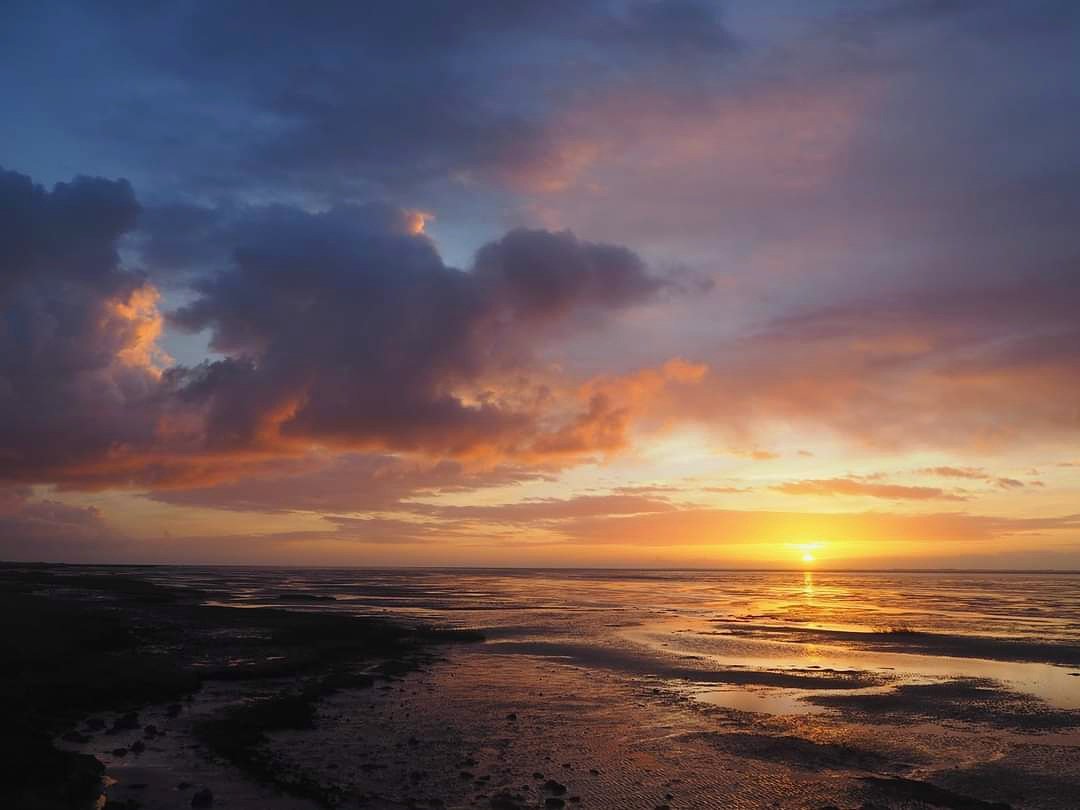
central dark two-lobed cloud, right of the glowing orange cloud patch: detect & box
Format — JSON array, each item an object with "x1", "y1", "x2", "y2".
[{"x1": 167, "y1": 201, "x2": 663, "y2": 454}]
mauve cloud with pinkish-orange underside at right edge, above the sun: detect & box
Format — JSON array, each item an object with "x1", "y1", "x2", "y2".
[{"x1": 681, "y1": 276, "x2": 1080, "y2": 453}]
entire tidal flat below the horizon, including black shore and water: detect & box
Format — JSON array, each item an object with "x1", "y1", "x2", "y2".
[{"x1": 0, "y1": 566, "x2": 1080, "y2": 810}]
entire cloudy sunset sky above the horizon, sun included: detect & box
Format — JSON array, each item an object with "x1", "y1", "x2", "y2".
[{"x1": 0, "y1": 0, "x2": 1080, "y2": 569}]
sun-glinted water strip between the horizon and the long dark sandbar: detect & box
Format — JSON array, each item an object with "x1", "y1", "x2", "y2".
[{"x1": 131, "y1": 566, "x2": 1080, "y2": 643}]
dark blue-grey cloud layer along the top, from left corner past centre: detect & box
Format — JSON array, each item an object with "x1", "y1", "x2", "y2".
[{"x1": 8, "y1": 0, "x2": 734, "y2": 197}]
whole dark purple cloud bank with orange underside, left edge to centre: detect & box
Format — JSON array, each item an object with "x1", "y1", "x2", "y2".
[{"x1": 0, "y1": 166, "x2": 667, "y2": 489}]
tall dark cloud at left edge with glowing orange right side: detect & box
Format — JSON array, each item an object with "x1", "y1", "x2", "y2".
[{"x1": 0, "y1": 171, "x2": 160, "y2": 477}]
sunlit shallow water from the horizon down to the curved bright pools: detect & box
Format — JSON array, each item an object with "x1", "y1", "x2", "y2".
[{"x1": 124, "y1": 567, "x2": 1080, "y2": 714}]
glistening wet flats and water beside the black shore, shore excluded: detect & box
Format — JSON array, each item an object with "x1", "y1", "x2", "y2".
[{"x1": 59, "y1": 568, "x2": 1080, "y2": 810}]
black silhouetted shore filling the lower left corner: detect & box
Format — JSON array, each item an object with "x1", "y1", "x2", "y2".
[{"x1": 0, "y1": 565, "x2": 477, "y2": 810}]
